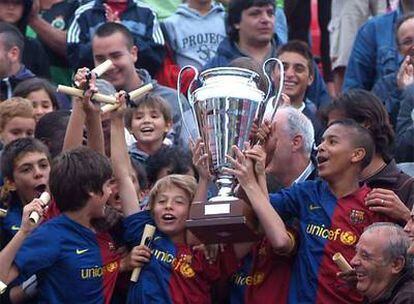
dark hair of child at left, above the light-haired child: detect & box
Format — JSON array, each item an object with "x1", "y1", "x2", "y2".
[{"x1": 13, "y1": 77, "x2": 59, "y2": 110}]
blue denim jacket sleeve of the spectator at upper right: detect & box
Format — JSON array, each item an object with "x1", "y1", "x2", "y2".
[{"x1": 343, "y1": 21, "x2": 376, "y2": 91}]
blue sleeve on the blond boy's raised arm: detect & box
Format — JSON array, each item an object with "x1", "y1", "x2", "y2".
[{"x1": 123, "y1": 210, "x2": 155, "y2": 247}]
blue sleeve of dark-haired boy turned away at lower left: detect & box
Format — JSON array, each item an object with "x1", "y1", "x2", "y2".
[{"x1": 14, "y1": 223, "x2": 60, "y2": 278}]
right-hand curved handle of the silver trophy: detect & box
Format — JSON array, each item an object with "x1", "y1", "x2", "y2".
[{"x1": 258, "y1": 58, "x2": 285, "y2": 125}]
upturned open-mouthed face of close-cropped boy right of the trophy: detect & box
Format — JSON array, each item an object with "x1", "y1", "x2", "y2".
[{"x1": 317, "y1": 124, "x2": 359, "y2": 180}]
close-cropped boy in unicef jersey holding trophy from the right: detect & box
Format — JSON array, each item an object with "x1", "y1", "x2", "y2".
[{"x1": 229, "y1": 120, "x2": 388, "y2": 303}]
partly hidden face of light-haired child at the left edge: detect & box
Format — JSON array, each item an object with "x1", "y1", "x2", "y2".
[{"x1": 0, "y1": 116, "x2": 36, "y2": 145}]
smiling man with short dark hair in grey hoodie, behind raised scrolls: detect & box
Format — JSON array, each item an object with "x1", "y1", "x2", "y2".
[{"x1": 92, "y1": 22, "x2": 196, "y2": 148}]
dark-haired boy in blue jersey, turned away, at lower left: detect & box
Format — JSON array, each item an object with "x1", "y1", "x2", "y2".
[{"x1": 0, "y1": 148, "x2": 112, "y2": 303}]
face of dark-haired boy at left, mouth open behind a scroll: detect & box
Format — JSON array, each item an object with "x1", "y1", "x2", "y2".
[{"x1": 11, "y1": 152, "x2": 50, "y2": 204}]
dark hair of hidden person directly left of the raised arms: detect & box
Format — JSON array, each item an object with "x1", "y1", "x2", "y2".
[{"x1": 35, "y1": 110, "x2": 71, "y2": 158}]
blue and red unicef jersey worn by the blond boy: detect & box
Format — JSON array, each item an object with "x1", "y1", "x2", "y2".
[{"x1": 124, "y1": 211, "x2": 233, "y2": 304}]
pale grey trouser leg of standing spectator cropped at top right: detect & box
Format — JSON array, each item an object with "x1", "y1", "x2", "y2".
[{"x1": 328, "y1": 0, "x2": 387, "y2": 93}]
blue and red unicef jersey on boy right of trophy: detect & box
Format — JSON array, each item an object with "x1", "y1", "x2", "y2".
[{"x1": 270, "y1": 181, "x2": 389, "y2": 304}]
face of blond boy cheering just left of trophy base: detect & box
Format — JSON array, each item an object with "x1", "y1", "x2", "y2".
[{"x1": 152, "y1": 185, "x2": 190, "y2": 241}]
